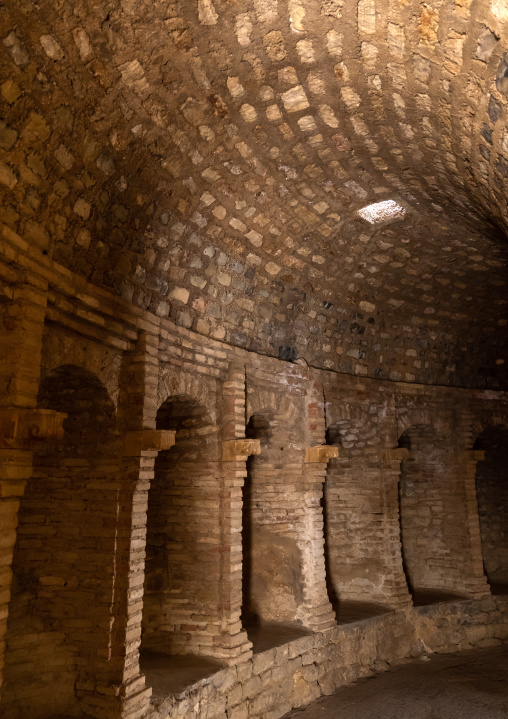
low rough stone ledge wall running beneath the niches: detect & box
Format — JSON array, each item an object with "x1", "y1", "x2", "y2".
[{"x1": 149, "y1": 598, "x2": 508, "y2": 719}]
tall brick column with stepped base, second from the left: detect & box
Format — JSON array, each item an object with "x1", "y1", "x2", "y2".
[{"x1": 78, "y1": 330, "x2": 162, "y2": 719}]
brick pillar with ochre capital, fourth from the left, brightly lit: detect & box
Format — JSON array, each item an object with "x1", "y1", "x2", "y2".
[{"x1": 297, "y1": 445, "x2": 339, "y2": 632}]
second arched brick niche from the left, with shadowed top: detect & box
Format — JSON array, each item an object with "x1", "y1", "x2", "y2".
[{"x1": 142, "y1": 395, "x2": 221, "y2": 656}]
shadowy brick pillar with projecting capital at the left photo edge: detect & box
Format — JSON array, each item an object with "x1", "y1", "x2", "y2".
[{"x1": 0, "y1": 278, "x2": 47, "y2": 701}]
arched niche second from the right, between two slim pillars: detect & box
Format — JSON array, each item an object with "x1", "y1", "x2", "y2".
[{"x1": 399, "y1": 424, "x2": 469, "y2": 606}]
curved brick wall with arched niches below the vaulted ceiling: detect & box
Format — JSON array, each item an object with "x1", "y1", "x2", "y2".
[{"x1": 0, "y1": 236, "x2": 508, "y2": 719}]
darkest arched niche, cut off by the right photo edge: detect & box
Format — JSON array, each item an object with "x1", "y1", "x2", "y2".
[{"x1": 474, "y1": 425, "x2": 508, "y2": 594}]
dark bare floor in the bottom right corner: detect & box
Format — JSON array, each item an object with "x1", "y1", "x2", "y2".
[{"x1": 286, "y1": 645, "x2": 508, "y2": 719}]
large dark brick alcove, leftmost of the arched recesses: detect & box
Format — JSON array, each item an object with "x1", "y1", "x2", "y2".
[{"x1": 2, "y1": 365, "x2": 120, "y2": 719}]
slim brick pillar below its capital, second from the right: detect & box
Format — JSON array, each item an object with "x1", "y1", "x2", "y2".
[{"x1": 380, "y1": 448, "x2": 412, "y2": 609}]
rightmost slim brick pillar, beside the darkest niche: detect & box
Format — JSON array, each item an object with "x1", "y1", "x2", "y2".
[{"x1": 457, "y1": 450, "x2": 490, "y2": 599}]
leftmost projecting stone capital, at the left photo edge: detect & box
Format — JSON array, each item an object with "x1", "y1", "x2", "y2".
[{"x1": 0, "y1": 407, "x2": 67, "y2": 449}]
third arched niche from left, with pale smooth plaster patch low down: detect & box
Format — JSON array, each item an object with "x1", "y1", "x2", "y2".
[{"x1": 242, "y1": 408, "x2": 303, "y2": 632}]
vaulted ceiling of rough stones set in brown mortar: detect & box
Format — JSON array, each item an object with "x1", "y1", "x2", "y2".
[{"x1": 0, "y1": 0, "x2": 508, "y2": 387}]
